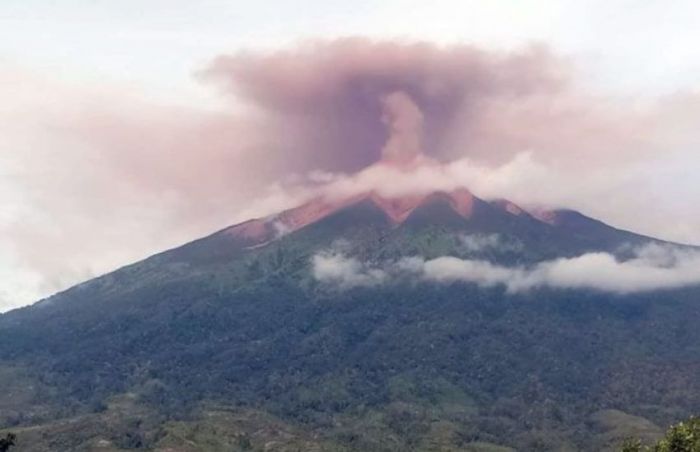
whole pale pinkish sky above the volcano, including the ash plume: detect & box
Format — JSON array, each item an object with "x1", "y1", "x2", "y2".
[{"x1": 0, "y1": 0, "x2": 700, "y2": 311}]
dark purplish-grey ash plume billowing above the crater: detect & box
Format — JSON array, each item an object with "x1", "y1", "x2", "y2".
[{"x1": 200, "y1": 38, "x2": 568, "y2": 172}]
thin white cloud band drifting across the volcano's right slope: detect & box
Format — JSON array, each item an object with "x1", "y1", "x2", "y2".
[{"x1": 312, "y1": 244, "x2": 700, "y2": 294}]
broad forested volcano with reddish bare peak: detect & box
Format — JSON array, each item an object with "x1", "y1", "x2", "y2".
[{"x1": 0, "y1": 189, "x2": 700, "y2": 451}]
